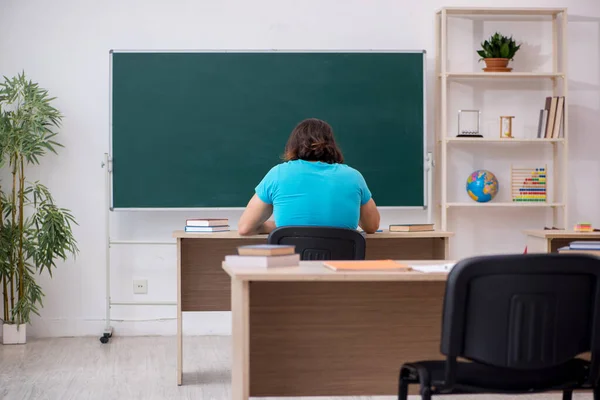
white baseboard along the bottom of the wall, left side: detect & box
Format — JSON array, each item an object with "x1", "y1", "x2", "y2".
[{"x1": 27, "y1": 311, "x2": 231, "y2": 338}]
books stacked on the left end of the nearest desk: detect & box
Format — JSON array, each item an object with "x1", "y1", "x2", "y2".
[{"x1": 225, "y1": 244, "x2": 300, "y2": 268}]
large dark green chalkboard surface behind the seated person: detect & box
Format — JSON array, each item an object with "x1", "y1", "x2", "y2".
[{"x1": 110, "y1": 51, "x2": 425, "y2": 209}]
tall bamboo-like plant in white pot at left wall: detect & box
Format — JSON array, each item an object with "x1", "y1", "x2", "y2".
[{"x1": 0, "y1": 73, "x2": 78, "y2": 344}]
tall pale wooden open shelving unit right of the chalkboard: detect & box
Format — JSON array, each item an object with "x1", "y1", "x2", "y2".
[{"x1": 435, "y1": 7, "x2": 569, "y2": 231}]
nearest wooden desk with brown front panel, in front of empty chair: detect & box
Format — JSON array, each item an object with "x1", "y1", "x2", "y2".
[{"x1": 223, "y1": 261, "x2": 447, "y2": 400}]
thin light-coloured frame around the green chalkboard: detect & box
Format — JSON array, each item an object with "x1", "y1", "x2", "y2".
[{"x1": 106, "y1": 49, "x2": 432, "y2": 211}]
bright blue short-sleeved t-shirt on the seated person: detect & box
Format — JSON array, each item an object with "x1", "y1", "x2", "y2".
[{"x1": 256, "y1": 160, "x2": 371, "y2": 229}]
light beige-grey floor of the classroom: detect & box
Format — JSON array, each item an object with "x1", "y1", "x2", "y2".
[{"x1": 0, "y1": 336, "x2": 592, "y2": 400}]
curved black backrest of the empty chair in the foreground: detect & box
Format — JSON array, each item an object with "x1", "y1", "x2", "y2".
[{"x1": 441, "y1": 254, "x2": 600, "y2": 383}]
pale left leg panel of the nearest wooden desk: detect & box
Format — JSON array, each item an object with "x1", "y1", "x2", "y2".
[{"x1": 231, "y1": 279, "x2": 250, "y2": 400}]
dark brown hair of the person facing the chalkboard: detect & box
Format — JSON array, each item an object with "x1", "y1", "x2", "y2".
[{"x1": 283, "y1": 118, "x2": 344, "y2": 164}]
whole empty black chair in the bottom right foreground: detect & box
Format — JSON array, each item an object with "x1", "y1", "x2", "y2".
[{"x1": 398, "y1": 254, "x2": 600, "y2": 400}]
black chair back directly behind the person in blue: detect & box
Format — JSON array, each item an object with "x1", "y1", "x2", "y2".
[{"x1": 268, "y1": 226, "x2": 366, "y2": 261}]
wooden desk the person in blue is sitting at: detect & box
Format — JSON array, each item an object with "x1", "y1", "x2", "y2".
[{"x1": 173, "y1": 231, "x2": 453, "y2": 385}]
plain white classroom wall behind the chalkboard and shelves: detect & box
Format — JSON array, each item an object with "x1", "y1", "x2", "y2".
[{"x1": 0, "y1": 0, "x2": 600, "y2": 336}]
